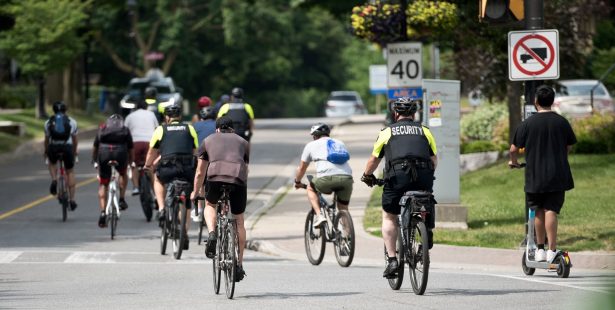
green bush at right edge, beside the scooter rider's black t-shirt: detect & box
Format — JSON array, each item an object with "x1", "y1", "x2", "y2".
[{"x1": 572, "y1": 114, "x2": 615, "y2": 154}]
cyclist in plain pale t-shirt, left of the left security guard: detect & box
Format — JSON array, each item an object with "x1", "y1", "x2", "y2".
[{"x1": 124, "y1": 100, "x2": 158, "y2": 195}]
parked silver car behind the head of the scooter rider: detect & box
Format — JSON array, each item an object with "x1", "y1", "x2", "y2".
[{"x1": 553, "y1": 80, "x2": 615, "y2": 117}]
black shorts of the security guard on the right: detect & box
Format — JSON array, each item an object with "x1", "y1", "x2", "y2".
[{"x1": 382, "y1": 168, "x2": 434, "y2": 215}]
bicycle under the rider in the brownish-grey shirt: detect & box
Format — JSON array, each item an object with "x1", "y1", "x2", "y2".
[{"x1": 196, "y1": 185, "x2": 239, "y2": 299}]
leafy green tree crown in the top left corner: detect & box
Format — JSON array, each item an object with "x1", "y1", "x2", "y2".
[{"x1": 0, "y1": 0, "x2": 90, "y2": 74}]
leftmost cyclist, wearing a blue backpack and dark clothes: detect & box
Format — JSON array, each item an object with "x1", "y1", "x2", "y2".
[{"x1": 43, "y1": 101, "x2": 78, "y2": 210}]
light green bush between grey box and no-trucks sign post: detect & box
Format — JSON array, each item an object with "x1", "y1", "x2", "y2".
[{"x1": 461, "y1": 104, "x2": 508, "y2": 141}]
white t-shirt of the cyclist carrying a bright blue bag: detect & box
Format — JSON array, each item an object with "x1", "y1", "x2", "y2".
[{"x1": 301, "y1": 137, "x2": 352, "y2": 178}]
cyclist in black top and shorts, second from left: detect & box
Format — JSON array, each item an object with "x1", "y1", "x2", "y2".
[{"x1": 92, "y1": 114, "x2": 134, "y2": 228}]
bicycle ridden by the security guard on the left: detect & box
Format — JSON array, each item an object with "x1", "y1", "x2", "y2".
[{"x1": 160, "y1": 179, "x2": 192, "y2": 259}]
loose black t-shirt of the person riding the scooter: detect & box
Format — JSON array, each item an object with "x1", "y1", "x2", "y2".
[{"x1": 512, "y1": 112, "x2": 577, "y2": 193}]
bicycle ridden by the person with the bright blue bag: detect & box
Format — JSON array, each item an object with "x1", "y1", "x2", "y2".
[{"x1": 302, "y1": 175, "x2": 355, "y2": 267}]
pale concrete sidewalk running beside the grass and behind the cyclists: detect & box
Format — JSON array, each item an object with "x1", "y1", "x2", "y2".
[{"x1": 246, "y1": 116, "x2": 615, "y2": 270}]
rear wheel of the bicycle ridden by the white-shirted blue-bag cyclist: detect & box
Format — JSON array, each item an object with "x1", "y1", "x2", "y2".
[{"x1": 333, "y1": 210, "x2": 355, "y2": 267}]
